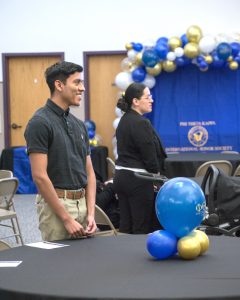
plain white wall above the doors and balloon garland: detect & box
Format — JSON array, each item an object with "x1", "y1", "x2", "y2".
[{"x1": 0, "y1": 0, "x2": 240, "y2": 146}]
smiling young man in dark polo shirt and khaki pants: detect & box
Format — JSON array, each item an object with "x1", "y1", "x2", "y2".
[{"x1": 25, "y1": 61, "x2": 96, "y2": 241}]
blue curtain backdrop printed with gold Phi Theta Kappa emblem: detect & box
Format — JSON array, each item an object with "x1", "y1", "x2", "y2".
[{"x1": 146, "y1": 65, "x2": 240, "y2": 152}]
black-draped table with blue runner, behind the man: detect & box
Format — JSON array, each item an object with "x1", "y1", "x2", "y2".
[{"x1": 0, "y1": 146, "x2": 108, "y2": 194}]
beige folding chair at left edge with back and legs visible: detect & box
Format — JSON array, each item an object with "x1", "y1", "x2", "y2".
[{"x1": 0, "y1": 177, "x2": 23, "y2": 245}]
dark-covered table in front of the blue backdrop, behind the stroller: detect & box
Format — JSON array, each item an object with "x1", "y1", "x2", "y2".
[{"x1": 165, "y1": 152, "x2": 240, "y2": 178}]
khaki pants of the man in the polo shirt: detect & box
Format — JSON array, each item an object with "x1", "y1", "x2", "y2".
[{"x1": 36, "y1": 194, "x2": 87, "y2": 241}]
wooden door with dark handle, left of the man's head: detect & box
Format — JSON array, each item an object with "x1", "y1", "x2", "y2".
[{"x1": 5, "y1": 54, "x2": 63, "y2": 147}]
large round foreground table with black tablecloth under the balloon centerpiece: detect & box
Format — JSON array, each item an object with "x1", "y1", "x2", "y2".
[{"x1": 0, "y1": 235, "x2": 240, "y2": 300}]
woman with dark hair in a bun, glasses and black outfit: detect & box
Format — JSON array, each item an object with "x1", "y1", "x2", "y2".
[{"x1": 114, "y1": 83, "x2": 167, "y2": 234}]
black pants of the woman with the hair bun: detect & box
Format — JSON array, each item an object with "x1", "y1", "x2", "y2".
[{"x1": 113, "y1": 170, "x2": 161, "y2": 234}]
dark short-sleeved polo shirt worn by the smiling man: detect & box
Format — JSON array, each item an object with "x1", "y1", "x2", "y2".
[{"x1": 24, "y1": 99, "x2": 90, "y2": 190}]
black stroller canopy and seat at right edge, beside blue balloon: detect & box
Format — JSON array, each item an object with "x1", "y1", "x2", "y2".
[{"x1": 201, "y1": 165, "x2": 240, "y2": 235}]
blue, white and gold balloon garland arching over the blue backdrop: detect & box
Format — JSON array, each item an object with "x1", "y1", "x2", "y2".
[{"x1": 115, "y1": 25, "x2": 240, "y2": 90}]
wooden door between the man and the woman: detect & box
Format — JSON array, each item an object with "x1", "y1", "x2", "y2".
[{"x1": 84, "y1": 51, "x2": 126, "y2": 158}]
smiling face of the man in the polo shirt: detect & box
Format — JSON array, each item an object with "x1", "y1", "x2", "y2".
[{"x1": 61, "y1": 72, "x2": 85, "y2": 106}]
